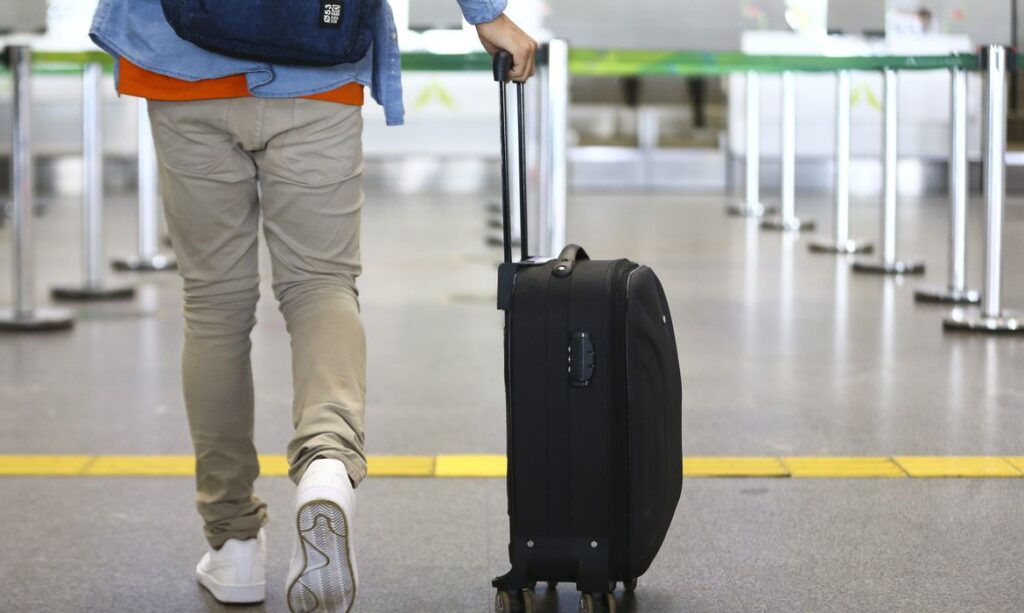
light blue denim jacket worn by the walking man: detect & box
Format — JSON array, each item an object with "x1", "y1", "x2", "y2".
[{"x1": 89, "y1": 0, "x2": 507, "y2": 126}]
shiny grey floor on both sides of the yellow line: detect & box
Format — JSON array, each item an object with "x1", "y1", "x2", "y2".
[{"x1": 0, "y1": 188, "x2": 1024, "y2": 612}]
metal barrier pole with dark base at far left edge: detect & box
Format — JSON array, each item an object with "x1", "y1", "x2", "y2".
[{"x1": 0, "y1": 46, "x2": 74, "y2": 332}]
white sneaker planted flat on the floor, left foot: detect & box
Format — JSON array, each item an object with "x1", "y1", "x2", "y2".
[{"x1": 196, "y1": 528, "x2": 266, "y2": 603}]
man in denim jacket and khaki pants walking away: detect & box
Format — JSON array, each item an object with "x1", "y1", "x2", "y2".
[{"x1": 91, "y1": 0, "x2": 537, "y2": 612}]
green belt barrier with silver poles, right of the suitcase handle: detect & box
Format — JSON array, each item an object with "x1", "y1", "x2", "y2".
[{"x1": 569, "y1": 45, "x2": 1024, "y2": 334}]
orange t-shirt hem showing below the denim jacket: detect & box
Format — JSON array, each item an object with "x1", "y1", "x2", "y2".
[{"x1": 118, "y1": 57, "x2": 362, "y2": 106}]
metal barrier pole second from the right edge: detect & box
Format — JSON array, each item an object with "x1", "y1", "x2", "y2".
[{"x1": 913, "y1": 69, "x2": 981, "y2": 304}]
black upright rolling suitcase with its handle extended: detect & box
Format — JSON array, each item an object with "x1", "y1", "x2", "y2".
[{"x1": 493, "y1": 53, "x2": 682, "y2": 613}]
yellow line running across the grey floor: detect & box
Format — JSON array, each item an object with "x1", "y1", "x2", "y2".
[{"x1": 0, "y1": 454, "x2": 1024, "y2": 479}]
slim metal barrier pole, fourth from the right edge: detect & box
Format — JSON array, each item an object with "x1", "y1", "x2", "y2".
[{"x1": 809, "y1": 71, "x2": 873, "y2": 254}]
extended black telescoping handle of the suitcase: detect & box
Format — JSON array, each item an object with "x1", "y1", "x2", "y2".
[{"x1": 494, "y1": 50, "x2": 529, "y2": 264}]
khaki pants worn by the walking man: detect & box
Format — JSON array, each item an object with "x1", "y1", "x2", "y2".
[{"x1": 150, "y1": 98, "x2": 367, "y2": 548}]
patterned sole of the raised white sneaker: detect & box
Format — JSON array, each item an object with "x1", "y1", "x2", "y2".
[{"x1": 288, "y1": 500, "x2": 355, "y2": 613}]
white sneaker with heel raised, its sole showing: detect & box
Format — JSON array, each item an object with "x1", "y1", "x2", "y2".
[{"x1": 287, "y1": 459, "x2": 358, "y2": 613}]
